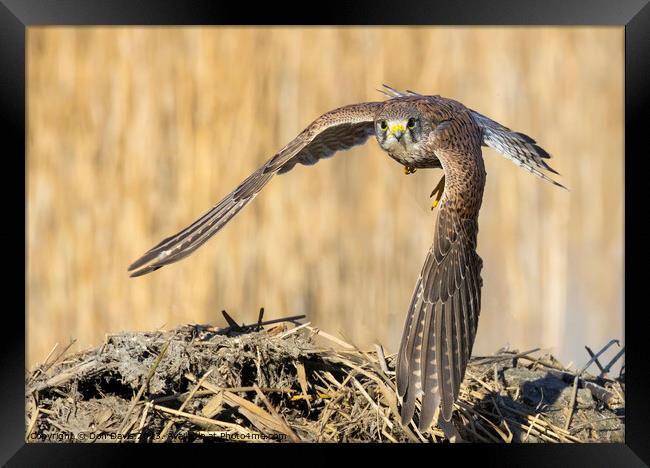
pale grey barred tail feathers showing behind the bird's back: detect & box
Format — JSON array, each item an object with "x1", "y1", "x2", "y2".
[{"x1": 378, "y1": 85, "x2": 566, "y2": 189}]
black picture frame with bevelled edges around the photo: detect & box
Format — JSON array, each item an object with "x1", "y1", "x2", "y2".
[{"x1": 0, "y1": 0, "x2": 650, "y2": 466}]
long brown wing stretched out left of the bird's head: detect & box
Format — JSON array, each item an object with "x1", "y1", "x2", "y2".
[{"x1": 129, "y1": 102, "x2": 382, "y2": 276}]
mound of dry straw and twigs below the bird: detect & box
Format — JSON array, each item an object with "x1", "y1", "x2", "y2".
[{"x1": 26, "y1": 317, "x2": 625, "y2": 442}]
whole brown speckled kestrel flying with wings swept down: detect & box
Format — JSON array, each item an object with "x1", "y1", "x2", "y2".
[{"x1": 129, "y1": 85, "x2": 563, "y2": 432}]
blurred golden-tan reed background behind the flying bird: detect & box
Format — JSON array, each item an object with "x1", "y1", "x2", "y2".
[{"x1": 27, "y1": 27, "x2": 624, "y2": 372}]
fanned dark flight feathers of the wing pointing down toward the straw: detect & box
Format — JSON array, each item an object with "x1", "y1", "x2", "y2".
[{"x1": 397, "y1": 205, "x2": 483, "y2": 431}]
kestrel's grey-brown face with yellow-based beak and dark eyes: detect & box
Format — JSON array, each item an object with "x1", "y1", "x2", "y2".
[{"x1": 375, "y1": 106, "x2": 425, "y2": 154}]
